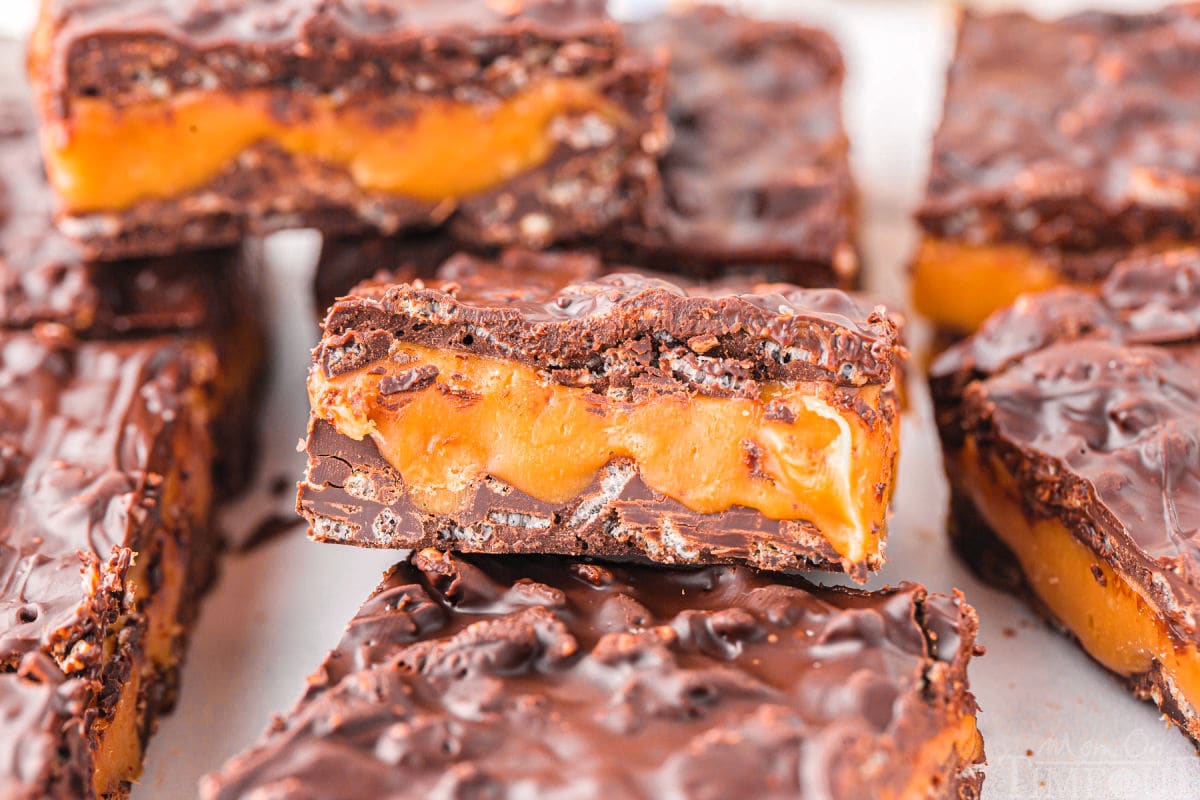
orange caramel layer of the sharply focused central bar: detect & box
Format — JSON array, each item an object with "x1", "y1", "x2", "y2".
[{"x1": 308, "y1": 343, "x2": 899, "y2": 560}]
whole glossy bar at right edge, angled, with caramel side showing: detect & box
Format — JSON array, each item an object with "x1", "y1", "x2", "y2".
[{"x1": 932, "y1": 251, "x2": 1200, "y2": 745}]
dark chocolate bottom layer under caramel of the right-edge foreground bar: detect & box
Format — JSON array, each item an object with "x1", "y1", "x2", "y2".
[{"x1": 949, "y1": 491, "x2": 1200, "y2": 751}]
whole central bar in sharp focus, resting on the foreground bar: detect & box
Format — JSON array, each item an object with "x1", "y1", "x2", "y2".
[{"x1": 299, "y1": 251, "x2": 902, "y2": 579}]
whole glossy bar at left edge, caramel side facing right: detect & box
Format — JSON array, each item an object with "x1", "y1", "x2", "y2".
[{"x1": 0, "y1": 329, "x2": 216, "y2": 799}]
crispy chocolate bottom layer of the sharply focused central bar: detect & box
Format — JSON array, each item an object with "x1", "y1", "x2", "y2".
[{"x1": 298, "y1": 421, "x2": 864, "y2": 578}]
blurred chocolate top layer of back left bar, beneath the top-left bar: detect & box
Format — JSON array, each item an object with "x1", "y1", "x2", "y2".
[{"x1": 0, "y1": 38, "x2": 241, "y2": 336}]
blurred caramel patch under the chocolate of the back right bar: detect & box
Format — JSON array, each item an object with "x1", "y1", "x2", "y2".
[{"x1": 912, "y1": 236, "x2": 1063, "y2": 333}]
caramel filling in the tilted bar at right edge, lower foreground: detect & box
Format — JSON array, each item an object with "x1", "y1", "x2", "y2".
[{"x1": 956, "y1": 448, "x2": 1200, "y2": 708}]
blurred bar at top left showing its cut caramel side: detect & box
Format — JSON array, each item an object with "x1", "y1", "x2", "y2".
[{"x1": 30, "y1": 0, "x2": 667, "y2": 259}]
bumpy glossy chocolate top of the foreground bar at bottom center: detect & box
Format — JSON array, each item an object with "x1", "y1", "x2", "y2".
[{"x1": 202, "y1": 551, "x2": 974, "y2": 800}]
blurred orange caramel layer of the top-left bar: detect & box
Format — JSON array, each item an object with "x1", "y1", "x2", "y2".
[{"x1": 43, "y1": 79, "x2": 619, "y2": 213}]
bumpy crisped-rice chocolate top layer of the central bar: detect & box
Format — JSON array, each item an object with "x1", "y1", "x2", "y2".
[{"x1": 314, "y1": 251, "x2": 902, "y2": 393}]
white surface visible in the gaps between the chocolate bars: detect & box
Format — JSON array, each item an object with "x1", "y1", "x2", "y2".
[{"x1": 11, "y1": 0, "x2": 1200, "y2": 800}]
